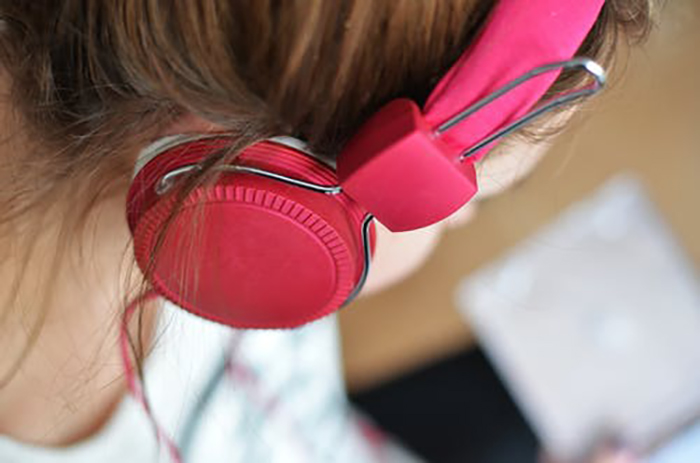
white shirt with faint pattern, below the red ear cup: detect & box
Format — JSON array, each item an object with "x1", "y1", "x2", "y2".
[{"x1": 0, "y1": 304, "x2": 418, "y2": 463}]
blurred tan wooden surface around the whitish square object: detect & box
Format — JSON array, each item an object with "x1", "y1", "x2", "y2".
[{"x1": 341, "y1": 0, "x2": 700, "y2": 390}]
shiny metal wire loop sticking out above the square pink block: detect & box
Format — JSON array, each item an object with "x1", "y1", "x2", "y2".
[{"x1": 435, "y1": 58, "x2": 607, "y2": 162}]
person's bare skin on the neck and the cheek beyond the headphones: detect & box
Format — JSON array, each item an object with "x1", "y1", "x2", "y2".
[{"x1": 0, "y1": 76, "x2": 627, "y2": 461}]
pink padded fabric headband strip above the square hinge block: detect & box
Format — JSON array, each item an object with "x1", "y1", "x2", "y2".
[{"x1": 423, "y1": 0, "x2": 605, "y2": 159}]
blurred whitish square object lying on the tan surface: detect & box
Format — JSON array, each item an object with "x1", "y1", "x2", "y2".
[{"x1": 456, "y1": 177, "x2": 700, "y2": 461}]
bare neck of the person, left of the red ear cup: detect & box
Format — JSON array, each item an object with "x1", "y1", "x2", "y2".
[{"x1": 0, "y1": 187, "x2": 155, "y2": 445}]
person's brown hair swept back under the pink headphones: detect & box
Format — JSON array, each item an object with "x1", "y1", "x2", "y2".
[{"x1": 0, "y1": 0, "x2": 654, "y2": 380}]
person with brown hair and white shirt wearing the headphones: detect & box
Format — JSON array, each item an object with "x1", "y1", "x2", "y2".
[{"x1": 0, "y1": 0, "x2": 651, "y2": 463}]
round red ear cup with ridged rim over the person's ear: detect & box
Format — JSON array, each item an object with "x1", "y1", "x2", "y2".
[{"x1": 128, "y1": 137, "x2": 374, "y2": 328}]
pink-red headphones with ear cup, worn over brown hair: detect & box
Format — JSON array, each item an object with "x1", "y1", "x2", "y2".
[{"x1": 127, "y1": 0, "x2": 604, "y2": 328}]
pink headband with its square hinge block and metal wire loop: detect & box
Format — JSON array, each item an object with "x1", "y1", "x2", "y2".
[{"x1": 337, "y1": 0, "x2": 605, "y2": 231}]
